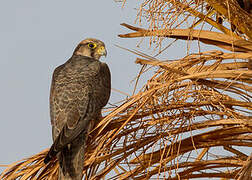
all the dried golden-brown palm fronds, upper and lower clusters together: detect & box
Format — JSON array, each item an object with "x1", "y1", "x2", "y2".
[{"x1": 0, "y1": 0, "x2": 252, "y2": 180}]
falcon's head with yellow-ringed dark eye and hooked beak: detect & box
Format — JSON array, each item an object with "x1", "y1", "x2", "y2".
[{"x1": 74, "y1": 38, "x2": 107, "y2": 60}]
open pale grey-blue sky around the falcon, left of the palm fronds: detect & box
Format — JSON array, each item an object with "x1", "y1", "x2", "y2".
[{"x1": 0, "y1": 0, "x2": 185, "y2": 174}]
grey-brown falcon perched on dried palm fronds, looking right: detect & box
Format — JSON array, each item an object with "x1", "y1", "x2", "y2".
[{"x1": 44, "y1": 38, "x2": 111, "y2": 180}]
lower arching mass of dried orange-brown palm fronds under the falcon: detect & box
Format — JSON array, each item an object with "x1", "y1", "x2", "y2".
[{"x1": 2, "y1": 48, "x2": 252, "y2": 179}]
